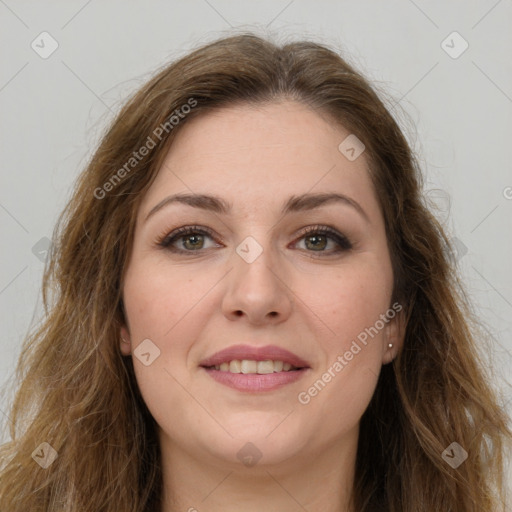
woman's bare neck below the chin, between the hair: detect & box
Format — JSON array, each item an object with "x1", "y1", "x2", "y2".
[{"x1": 160, "y1": 430, "x2": 358, "y2": 512}]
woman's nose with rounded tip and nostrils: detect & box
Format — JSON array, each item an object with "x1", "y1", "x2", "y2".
[{"x1": 222, "y1": 239, "x2": 293, "y2": 325}]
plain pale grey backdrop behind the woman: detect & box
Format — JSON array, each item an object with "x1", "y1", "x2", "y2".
[{"x1": 0, "y1": 0, "x2": 512, "y2": 486}]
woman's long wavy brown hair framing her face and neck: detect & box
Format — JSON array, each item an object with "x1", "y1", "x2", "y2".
[{"x1": 0, "y1": 33, "x2": 511, "y2": 512}]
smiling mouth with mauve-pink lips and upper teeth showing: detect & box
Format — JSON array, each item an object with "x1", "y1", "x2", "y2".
[{"x1": 200, "y1": 345, "x2": 310, "y2": 392}]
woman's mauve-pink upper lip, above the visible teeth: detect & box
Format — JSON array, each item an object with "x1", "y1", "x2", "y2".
[{"x1": 199, "y1": 345, "x2": 309, "y2": 368}]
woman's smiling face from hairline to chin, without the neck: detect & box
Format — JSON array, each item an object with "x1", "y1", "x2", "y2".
[{"x1": 120, "y1": 101, "x2": 401, "y2": 465}]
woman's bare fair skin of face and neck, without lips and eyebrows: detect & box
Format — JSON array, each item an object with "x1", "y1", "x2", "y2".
[{"x1": 120, "y1": 101, "x2": 403, "y2": 512}]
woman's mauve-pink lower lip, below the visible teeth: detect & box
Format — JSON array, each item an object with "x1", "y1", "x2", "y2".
[{"x1": 203, "y1": 367, "x2": 309, "y2": 392}]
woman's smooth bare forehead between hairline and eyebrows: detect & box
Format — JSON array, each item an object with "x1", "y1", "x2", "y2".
[{"x1": 141, "y1": 101, "x2": 377, "y2": 219}]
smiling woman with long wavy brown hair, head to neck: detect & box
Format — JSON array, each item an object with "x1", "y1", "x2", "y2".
[{"x1": 0, "y1": 34, "x2": 511, "y2": 512}]
